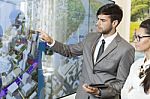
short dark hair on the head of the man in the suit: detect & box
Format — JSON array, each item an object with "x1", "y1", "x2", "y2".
[{"x1": 96, "y1": 3, "x2": 123, "y2": 24}]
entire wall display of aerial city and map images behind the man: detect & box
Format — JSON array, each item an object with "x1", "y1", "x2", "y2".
[{"x1": 0, "y1": 0, "x2": 112, "y2": 99}]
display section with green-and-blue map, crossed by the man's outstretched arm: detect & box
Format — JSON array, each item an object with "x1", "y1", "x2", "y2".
[{"x1": 37, "y1": 0, "x2": 112, "y2": 99}]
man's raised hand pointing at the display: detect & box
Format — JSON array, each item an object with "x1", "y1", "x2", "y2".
[{"x1": 37, "y1": 30, "x2": 53, "y2": 44}]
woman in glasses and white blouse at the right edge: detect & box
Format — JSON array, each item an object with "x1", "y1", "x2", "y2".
[{"x1": 121, "y1": 19, "x2": 150, "y2": 99}]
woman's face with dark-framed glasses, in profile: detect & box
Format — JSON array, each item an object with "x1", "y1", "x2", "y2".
[{"x1": 135, "y1": 28, "x2": 150, "y2": 52}]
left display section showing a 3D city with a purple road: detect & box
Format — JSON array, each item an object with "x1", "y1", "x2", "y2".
[{"x1": 0, "y1": 0, "x2": 38, "y2": 99}]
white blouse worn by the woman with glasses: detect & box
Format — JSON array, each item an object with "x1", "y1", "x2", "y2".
[{"x1": 121, "y1": 58, "x2": 150, "y2": 99}]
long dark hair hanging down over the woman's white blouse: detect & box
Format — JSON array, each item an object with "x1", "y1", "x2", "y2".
[{"x1": 142, "y1": 67, "x2": 150, "y2": 93}]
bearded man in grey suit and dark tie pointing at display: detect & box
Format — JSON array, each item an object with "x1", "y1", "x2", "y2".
[{"x1": 39, "y1": 3, "x2": 135, "y2": 99}]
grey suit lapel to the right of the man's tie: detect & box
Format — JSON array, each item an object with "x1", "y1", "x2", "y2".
[{"x1": 95, "y1": 34, "x2": 120, "y2": 65}]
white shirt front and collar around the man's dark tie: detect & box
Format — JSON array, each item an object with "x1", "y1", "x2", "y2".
[{"x1": 94, "y1": 32, "x2": 117, "y2": 63}]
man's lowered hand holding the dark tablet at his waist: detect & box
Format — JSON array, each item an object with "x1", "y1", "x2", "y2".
[{"x1": 82, "y1": 84, "x2": 100, "y2": 96}]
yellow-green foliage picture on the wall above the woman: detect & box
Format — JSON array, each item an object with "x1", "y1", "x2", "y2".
[{"x1": 130, "y1": 0, "x2": 150, "y2": 42}]
